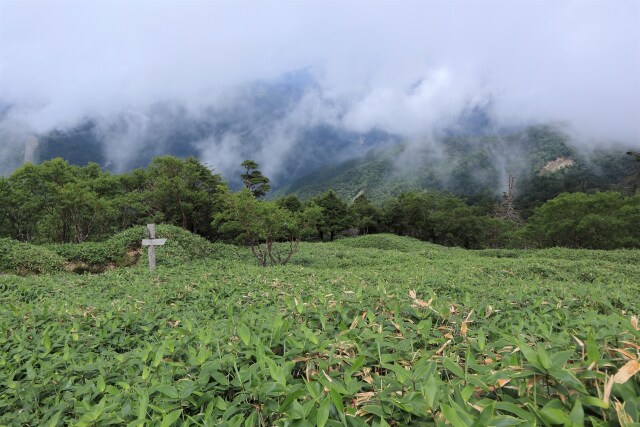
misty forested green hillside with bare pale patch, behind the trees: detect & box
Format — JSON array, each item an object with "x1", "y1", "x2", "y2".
[{"x1": 273, "y1": 126, "x2": 635, "y2": 208}]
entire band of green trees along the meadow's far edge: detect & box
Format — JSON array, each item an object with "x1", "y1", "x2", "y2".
[{"x1": 0, "y1": 157, "x2": 640, "y2": 251}]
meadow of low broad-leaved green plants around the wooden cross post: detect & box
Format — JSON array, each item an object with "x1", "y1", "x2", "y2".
[{"x1": 0, "y1": 232, "x2": 640, "y2": 427}]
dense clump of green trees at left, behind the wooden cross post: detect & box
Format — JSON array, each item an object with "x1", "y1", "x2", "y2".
[{"x1": 0, "y1": 157, "x2": 224, "y2": 243}]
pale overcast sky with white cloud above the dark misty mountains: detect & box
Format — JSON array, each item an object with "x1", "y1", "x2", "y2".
[{"x1": 0, "y1": 0, "x2": 640, "y2": 144}]
